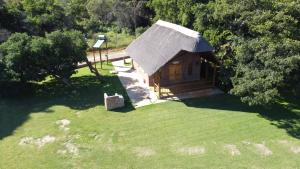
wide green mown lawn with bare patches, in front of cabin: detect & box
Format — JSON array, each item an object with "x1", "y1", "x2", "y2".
[{"x1": 0, "y1": 63, "x2": 300, "y2": 169}]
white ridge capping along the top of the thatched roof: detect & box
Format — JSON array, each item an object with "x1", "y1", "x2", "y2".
[{"x1": 155, "y1": 20, "x2": 201, "y2": 39}]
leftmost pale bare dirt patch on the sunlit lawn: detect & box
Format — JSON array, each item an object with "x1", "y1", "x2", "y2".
[{"x1": 19, "y1": 135, "x2": 56, "y2": 148}]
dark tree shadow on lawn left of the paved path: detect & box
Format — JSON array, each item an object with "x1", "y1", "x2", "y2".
[{"x1": 0, "y1": 75, "x2": 134, "y2": 140}]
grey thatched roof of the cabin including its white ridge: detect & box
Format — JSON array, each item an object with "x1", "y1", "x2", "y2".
[{"x1": 126, "y1": 20, "x2": 213, "y2": 75}]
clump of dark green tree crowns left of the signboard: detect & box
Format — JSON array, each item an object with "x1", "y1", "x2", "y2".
[{"x1": 0, "y1": 31, "x2": 87, "y2": 83}]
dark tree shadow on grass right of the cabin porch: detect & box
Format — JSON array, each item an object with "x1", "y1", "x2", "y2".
[{"x1": 183, "y1": 94, "x2": 300, "y2": 139}]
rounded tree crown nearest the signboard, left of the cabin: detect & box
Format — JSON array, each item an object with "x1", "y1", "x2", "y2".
[{"x1": 44, "y1": 31, "x2": 87, "y2": 85}]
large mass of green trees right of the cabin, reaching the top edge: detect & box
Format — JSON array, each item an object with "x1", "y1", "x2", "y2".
[{"x1": 194, "y1": 0, "x2": 300, "y2": 105}]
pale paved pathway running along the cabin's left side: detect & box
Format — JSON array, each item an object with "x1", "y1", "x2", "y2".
[{"x1": 112, "y1": 60, "x2": 165, "y2": 107}]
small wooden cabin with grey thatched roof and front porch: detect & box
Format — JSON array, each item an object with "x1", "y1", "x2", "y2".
[{"x1": 126, "y1": 20, "x2": 218, "y2": 97}]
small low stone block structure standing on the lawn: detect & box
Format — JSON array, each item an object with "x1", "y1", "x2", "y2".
[{"x1": 104, "y1": 93, "x2": 125, "y2": 110}]
